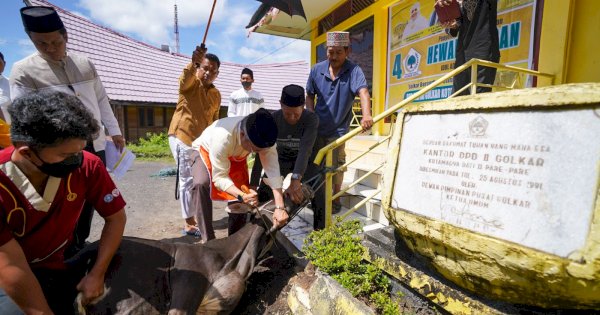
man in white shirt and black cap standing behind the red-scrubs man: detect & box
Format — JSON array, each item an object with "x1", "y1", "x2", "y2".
[{"x1": 10, "y1": 6, "x2": 125, "y2": 256}]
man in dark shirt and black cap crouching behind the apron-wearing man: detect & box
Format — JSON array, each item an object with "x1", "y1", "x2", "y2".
[{"x1": 250, "y1": 84, "x2": 325, "y2": 230}]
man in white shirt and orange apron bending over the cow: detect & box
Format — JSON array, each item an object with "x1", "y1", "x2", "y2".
[{"x1": 192, "y1": 108, "x2": 288, "y2": 241}]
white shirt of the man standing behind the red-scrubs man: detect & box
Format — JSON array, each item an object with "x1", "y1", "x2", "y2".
[{"x1": 10, "y1": 52, "x2": 121, "y2": 151}]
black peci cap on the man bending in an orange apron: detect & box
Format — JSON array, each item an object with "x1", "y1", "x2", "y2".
[{"x1": 246, "y1": 108, "x2": 278, "y2": 148}]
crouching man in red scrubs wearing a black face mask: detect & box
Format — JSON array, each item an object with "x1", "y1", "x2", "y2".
[{"x1": 0, "y1": 92, "x2": 126, "y2": 314}]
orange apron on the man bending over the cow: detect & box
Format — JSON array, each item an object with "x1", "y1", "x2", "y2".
[{"x1": 200, "y1": 146, "x2": 250, "y2": 201}]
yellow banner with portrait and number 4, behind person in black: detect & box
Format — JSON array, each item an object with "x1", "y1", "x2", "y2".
[{"x1": 386, "y1": 0, "x2": 534, "y2": 107}]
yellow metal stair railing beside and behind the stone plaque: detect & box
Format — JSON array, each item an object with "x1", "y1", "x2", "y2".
[{"x1": 314, "y1": 59, "x2": 554, "y2": 227}]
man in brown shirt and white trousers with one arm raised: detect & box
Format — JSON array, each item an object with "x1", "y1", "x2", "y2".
[{"x1": 169, "y1": 47, "x2": 221, "y2": 237}]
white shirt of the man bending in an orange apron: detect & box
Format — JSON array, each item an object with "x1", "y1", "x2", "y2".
[{"x1": 192, "y1": 117, "x2": 283, "y2": 191}]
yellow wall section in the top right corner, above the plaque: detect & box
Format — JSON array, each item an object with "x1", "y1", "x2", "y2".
[{"x1": 538, "y1": 0, "x2": 600, "y2": 84}]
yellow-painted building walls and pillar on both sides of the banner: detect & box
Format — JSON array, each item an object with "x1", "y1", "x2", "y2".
[{"x1": 311, "y1": 0, "x2": 600, "y2": 127}]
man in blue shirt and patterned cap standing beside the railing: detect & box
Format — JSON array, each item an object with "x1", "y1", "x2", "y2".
[{"x1": 306, "y1": 32, "x2": 373, "y2": 217}]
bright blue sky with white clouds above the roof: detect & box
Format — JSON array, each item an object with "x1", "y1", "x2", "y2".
[{"x1": 0, "y1": 0, "x2": 310, "y2": 77}]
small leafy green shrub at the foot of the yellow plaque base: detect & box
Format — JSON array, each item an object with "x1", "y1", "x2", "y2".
[{"x1": 304, "y1": 218, "x2": 400, "y2": 314}]
